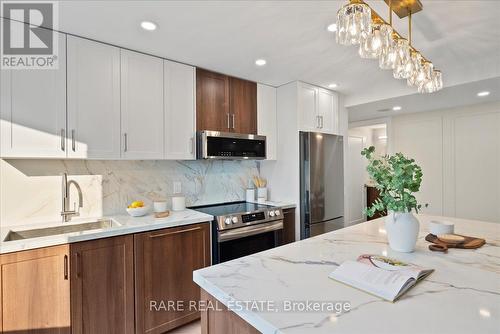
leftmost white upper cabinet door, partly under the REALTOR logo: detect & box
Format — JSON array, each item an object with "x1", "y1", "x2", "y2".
[{"x1": 0, "y1": 33, "x2": 66, "y2": 158}]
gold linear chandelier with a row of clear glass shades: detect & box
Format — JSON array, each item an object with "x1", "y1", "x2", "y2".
[{"x1": 336, "y1": 0, "x2": 443, "y2": 93}]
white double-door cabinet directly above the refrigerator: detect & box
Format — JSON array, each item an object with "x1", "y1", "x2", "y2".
[{"x1": 298, "y1": 82, "x2": 339, "y2": 134}]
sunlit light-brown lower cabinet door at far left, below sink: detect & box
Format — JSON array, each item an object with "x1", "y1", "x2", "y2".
[{"x1": 0, "y1": 245, "x2": 71, "y2": 334}]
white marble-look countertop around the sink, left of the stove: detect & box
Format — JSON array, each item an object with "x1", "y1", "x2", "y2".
[{"x1": 0, "y1": 209, "x2": 213, "y2": 254}]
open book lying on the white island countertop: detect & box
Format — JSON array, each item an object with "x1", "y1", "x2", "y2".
[{"x1": 329, "y1": 254, "x2": 434, "y2": 302}]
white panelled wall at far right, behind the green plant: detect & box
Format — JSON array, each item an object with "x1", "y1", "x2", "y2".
[{"x1": 389, "y1": 102, "x2": 500, "y2": 222}]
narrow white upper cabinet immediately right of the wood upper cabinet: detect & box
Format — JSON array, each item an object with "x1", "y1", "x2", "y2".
[{"x1": 257, "y1": 84, "x2": 278, "y2": 160}]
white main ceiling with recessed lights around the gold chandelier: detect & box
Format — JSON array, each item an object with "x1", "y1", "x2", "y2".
[{"x1": 11, "y1": 0, "x2": 500, "y2": 118}]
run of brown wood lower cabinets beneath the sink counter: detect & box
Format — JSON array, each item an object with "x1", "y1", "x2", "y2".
[{"x1": 0, "y1": 223, "x2": 210, "y2": 334}]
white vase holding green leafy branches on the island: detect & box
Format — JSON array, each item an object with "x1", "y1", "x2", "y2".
[{"x1": 385, "y1": 211, "x2": 420, "y2": 253}]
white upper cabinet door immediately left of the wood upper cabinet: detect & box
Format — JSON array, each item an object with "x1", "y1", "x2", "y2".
[{"x1": 163, "y1": 60, "x2": 196, "y2": 160}]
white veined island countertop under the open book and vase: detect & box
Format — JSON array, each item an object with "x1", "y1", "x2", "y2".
[{"x1": 193, "y1": 215, "x2": 500, "y2": 334}]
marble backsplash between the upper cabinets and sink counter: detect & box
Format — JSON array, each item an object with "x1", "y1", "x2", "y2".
[{"x1": 0, "y1": 159, "x2": 259, "y2": 226}]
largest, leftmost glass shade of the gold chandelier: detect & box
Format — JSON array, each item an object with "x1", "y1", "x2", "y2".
[{"x1": 336, "y1": 1, "x2": 372, "y2": 45}]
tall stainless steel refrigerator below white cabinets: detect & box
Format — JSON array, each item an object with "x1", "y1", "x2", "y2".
[{"x1": 300, "y1": 132, "x2": 344, "y2": 239}]
